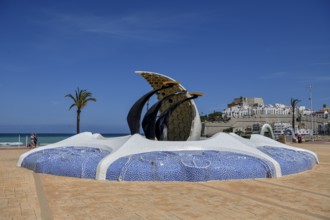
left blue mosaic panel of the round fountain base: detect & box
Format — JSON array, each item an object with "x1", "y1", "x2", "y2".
[{"x1": 22, "y1": 147, "x2": 110, "y2": 179}]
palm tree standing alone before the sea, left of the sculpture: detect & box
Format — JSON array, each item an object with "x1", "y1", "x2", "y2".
[{"x1": 65, "y1": 87, "x2": 96, "y2": 134}]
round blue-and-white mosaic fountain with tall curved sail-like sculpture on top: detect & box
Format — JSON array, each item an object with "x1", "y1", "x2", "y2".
[{"x1": 17, "y1": 72, "x2": 318, "y2": 182}]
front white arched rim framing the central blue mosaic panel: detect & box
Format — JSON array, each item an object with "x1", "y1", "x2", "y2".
[{"x1": 96, "y1": 133, "x2": 281, "y2": 180}]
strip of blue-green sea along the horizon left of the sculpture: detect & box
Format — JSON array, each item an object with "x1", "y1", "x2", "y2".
[{"x1": 0, "y1": 133, "x2": 128, "y2": 148}]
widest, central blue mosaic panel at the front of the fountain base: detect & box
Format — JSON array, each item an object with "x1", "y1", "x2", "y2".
[{"x1": 106, "y1": 151, "x2": 275, "y2": 182}]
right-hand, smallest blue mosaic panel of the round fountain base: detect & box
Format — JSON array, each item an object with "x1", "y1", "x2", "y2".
[{"x1": 258, "y1": 146, "x2": 317, "y2": 176}]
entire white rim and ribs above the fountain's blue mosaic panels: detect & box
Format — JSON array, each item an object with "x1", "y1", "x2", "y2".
[{"x1": 17, "y1": 132, "x2": 318, "y2": 180}]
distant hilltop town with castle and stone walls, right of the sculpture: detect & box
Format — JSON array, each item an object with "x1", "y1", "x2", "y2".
[{"x1": 202, "y1": 97, "x2": 330, "y2": 136}]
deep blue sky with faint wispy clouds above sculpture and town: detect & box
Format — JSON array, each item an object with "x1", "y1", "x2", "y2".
[{"x1": 0, "y1": 0, "x2": 330, "y2": 133}]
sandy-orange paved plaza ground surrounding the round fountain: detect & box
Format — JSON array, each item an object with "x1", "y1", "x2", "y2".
[{"x1": 0, "y1": 141, "x2": 330, "y2": 220}]
